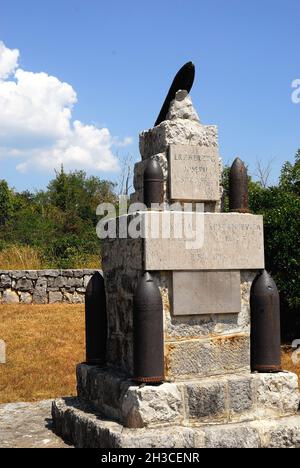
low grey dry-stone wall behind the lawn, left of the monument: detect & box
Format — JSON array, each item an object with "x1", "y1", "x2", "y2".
[{"x1": 0, "y1": 270, "x2": 99, "y2": 304}]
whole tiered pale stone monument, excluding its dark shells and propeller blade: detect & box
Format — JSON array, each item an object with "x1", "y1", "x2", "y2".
[{"x1": 53, "y1": 64, "x2": 300, "y2": 448}]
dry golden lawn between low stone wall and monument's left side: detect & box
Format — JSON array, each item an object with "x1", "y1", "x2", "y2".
[{"x1": 0, "y1": 304, "x2": 84, "y2": 403}]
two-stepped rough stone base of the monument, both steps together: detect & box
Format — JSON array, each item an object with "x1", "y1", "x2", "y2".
[{"x1": 53, "y1": 364, "x2": 300, "y2": 448}]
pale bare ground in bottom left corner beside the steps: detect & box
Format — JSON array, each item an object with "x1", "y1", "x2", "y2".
[{"x1": 0, "y1": 400, "x2": 69, "y2": 448}]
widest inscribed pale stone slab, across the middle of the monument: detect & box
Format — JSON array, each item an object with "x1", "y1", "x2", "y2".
[{"x1": 140, "y1": 212, "x2": 265, "y2": 271}]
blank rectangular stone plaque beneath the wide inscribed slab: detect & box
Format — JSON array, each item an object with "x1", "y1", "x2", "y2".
[{"x1": 173, "y1": 271, "x2": 241, "y2": 315}]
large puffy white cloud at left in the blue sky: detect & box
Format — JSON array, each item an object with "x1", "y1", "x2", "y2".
[{"x1": 0, "y1": 42, "x2": 132, "y2": 172}]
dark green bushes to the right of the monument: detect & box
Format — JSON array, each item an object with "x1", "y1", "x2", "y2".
[{"x1": 223, "y1": 154, "x2": 300, "y2": 341}]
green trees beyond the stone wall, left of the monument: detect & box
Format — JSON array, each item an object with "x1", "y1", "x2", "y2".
[{"x1": 0, "y1": 167, "x2": 116, "y2": 268}]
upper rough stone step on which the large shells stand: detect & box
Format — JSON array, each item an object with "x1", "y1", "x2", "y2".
[{"x1": 77, "y1": 364, "x2": 300, "y2": 428}]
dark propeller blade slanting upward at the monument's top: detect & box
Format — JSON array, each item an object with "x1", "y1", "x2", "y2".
[{"x1": 154, "y1": 62, "x2": 195, "y2": 127}]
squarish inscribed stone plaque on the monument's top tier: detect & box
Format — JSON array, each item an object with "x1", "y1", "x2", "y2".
[{"x1": 169, "y1": 145, "x2": 220, "y2": 202}]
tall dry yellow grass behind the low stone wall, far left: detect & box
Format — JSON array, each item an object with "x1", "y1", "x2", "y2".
[{"x1": 0, "y1": 245, "x2": 43, "y2": 270}]
